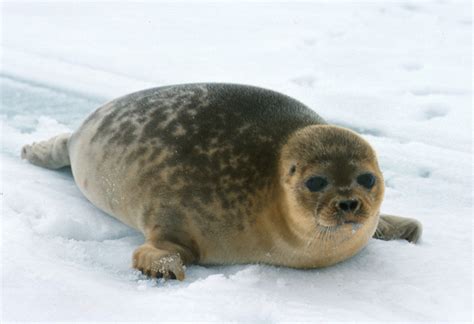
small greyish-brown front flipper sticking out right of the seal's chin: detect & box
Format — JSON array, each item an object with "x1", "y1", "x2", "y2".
[{"x1": 373, "y1": 215, "x2": 423, "y2": 243}]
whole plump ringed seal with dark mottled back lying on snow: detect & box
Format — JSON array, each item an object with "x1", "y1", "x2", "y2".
[{"x1": 22, "y1": 83, "x2": 421, "y2": 280}]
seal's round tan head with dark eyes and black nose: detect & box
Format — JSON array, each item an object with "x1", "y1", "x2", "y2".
[{"x1": 280, "y1": 125, "x2": 384, "y2": 266}]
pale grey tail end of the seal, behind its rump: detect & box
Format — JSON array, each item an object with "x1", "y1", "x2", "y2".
[{"x1": 21, "y1": 133, "x2": 71, "y2": 169}]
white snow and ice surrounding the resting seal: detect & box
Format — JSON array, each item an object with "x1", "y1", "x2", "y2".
[{"x1": 0, "y1": 0, "x2": 473, "y2": 322}]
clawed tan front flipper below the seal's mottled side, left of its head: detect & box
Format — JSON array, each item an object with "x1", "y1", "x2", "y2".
[{"x1": 132, "y1": 242, "x2": 196, "y2": 280}]
